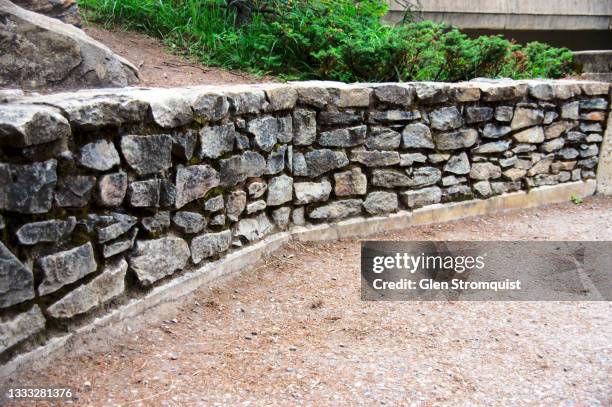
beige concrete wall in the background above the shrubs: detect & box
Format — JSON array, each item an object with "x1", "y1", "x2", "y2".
[{"x1": 387, "y1": 0, "x2": 612, "y2": 31}]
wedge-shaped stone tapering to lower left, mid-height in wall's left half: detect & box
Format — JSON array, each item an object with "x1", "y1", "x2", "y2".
[{"x1": 175, "y1": 165, "x2": 220, "y2": 209}]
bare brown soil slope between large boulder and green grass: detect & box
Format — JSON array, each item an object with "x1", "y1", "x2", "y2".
[{"x1": 83, "y1": 25, "x2": 274, "y2": 88}]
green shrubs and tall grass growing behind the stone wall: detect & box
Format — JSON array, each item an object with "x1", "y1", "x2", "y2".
[{"x1": 80, "y1": 0, "x2": 572, "y2": 82}]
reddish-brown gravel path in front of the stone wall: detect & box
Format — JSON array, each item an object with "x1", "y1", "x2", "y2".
[{"x1": 9, "y1": 198, "x2": 612, "y2": 406}]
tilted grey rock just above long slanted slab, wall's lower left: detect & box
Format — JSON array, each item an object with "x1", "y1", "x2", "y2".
[{"x1": 36, "y1": 243, "x2": 98, "y2": 295}]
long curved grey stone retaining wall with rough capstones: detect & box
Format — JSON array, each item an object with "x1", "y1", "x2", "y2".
[{"x1": 0, "y1": 81, "x2": 610, "y2": 364}]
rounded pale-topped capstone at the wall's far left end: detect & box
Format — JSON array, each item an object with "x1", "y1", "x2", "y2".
[{"x1": 0, "y1": 104, "x2": 71, "y2": 147}]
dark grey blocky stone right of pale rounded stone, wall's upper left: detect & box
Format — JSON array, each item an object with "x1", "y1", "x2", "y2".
[{"x1": 121, "y1": 134, "x2": 172, "y2": 175}]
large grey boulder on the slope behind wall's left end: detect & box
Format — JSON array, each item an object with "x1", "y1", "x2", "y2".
[{"x1": 0, "y1": 0, "x2": 138, "y2": 89}]
